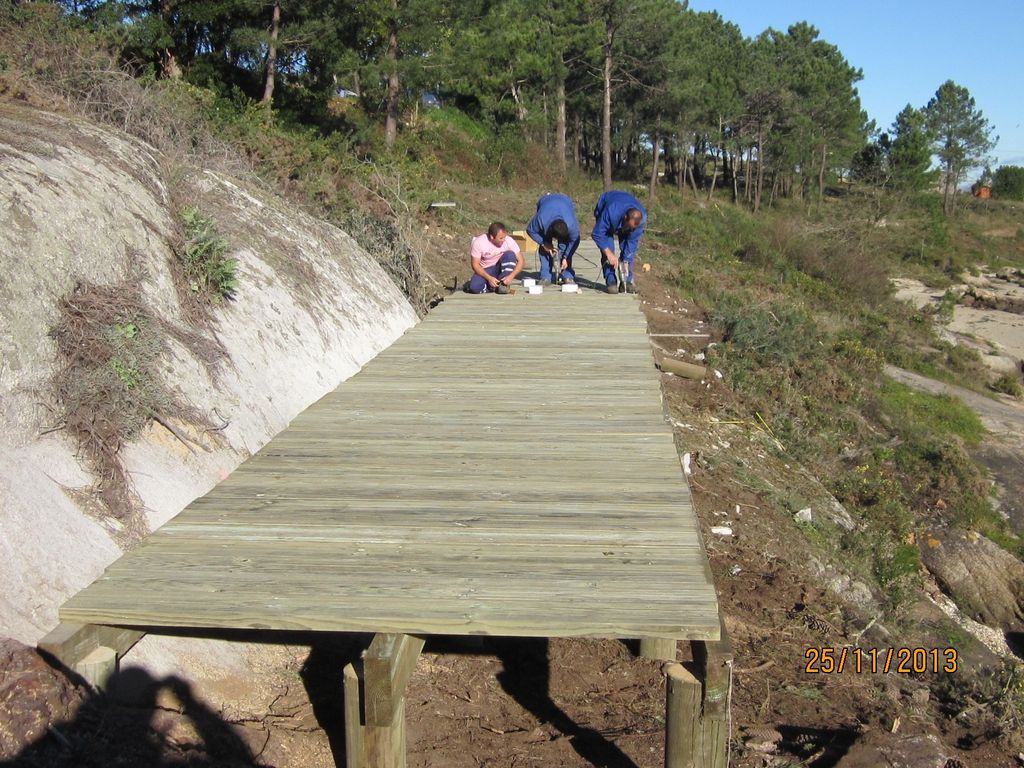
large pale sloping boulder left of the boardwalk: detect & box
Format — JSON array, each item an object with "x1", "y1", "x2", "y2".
[{"x1": 0, "y1": 100, "x2": 417, "y2": 684}]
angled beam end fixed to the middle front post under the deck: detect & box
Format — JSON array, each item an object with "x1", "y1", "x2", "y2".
[{"x1": 362, "y1": 634, "x2": 423, "y2": 726}]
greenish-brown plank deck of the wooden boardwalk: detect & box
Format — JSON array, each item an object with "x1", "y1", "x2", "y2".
[{"x1": 60, "y1": 291, "x2": 719, "y2": 639}]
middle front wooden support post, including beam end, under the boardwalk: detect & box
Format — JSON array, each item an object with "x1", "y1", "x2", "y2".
[{"x1": 344, "y1": 634, "x2": 424, "y2": 768}]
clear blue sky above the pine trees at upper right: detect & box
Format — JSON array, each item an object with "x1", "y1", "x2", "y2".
[{"x1": 689, "y1": 0, "x2": 1024, "y2": 168}]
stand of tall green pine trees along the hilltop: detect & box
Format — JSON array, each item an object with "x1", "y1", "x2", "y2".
[{"x1": 46, "y1": 0, "x2": 992, "y2": 210}]
